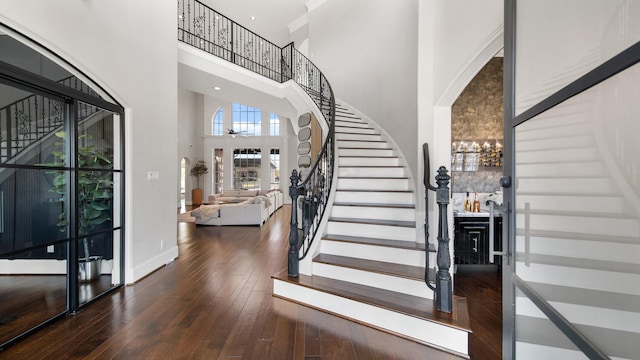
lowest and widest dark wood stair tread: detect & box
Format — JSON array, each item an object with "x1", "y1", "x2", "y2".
[{"x1": 272, "y1": 271, "x2": 472, "y2": 333}]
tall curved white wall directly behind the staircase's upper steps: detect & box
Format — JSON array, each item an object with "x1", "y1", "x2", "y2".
[{"x1": 308, "y1": 0, "x2": 418, "y2": 179}]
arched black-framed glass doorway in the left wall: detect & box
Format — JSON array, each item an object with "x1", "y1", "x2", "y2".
[{"x1": 0, "y1": 23, "x2": 125, "y2": 348}]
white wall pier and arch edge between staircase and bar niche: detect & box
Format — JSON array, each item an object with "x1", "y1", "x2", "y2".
[{"x1": 416, "y1": 0, "x2": 504, "y2": 233}]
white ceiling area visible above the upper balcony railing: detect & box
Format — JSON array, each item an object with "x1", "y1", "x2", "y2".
[{"x1": 200, "y1": 0, "x2": 309, "y2": 47}]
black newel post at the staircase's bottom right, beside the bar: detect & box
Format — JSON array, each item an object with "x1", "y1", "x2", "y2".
[{"x1": 434, "y1": 166, "x2": 453, "y2": 313}]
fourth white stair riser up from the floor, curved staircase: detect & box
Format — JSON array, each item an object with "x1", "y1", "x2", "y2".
[{"x1": 327, "y1": 220, "x2": 416, "y2": 241}]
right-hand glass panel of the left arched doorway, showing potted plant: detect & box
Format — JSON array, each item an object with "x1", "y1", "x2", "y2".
[{"x1": 77, "y1": 102, "x2": 122, "y2": 304}]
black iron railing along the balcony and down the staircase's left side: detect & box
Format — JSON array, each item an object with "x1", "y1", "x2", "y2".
[{"x1": 178, "y1": 0, "x2": 335, "y2": 276}]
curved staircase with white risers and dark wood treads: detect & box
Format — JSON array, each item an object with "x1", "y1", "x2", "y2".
[{"x1": 273, "y1": 105, "x2": 471, "y2": 357}]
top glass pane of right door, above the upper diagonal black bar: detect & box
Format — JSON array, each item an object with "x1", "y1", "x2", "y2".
[{"x1": 515, "y1": 0, "x2": 640, "y2": 115}]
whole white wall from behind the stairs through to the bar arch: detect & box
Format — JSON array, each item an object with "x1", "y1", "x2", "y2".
[{"x1": 308, "y1": 0, "x2": 503, "y2": 243}]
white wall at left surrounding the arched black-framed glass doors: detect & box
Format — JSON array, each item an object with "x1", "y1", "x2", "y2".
[{"x1": 0, "y1": 0, "x2": 178, "y2": 283}]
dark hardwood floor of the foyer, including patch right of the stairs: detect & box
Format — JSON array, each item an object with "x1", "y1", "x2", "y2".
[{"x1": 0, "y1": 206, "x2": 501, "y2": 360}]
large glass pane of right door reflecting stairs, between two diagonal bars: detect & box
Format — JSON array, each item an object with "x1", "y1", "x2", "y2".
[{"x1": 514, "y1": 65, "x2": 640, "y2": 359}]
